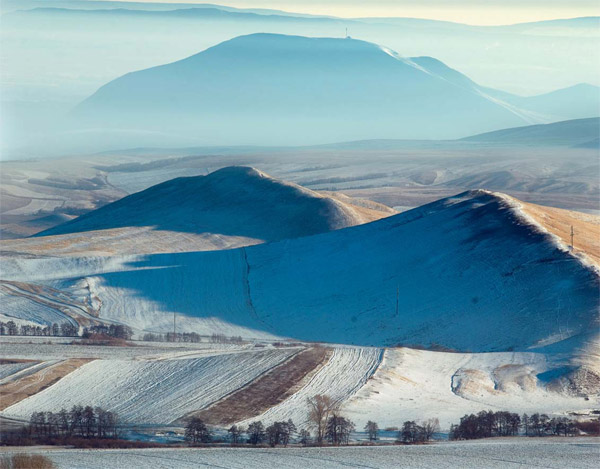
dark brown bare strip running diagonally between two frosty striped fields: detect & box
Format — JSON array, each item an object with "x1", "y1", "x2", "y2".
[{"x1": 183, "y1": 347, "x2": 332, "y2": 425}]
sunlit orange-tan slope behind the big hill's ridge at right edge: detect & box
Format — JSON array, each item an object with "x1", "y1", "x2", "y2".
[{"x1": 521, "y1": 202, "x2": 600, "y2": 265}]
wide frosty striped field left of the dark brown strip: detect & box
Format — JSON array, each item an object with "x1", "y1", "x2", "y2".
[{"x1": 4, "y1": 349, "x2": 297, "y2": 424}]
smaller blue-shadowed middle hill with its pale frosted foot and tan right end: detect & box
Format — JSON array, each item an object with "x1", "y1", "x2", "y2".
[{"x1": 25, "y1": 166, "x2": 395, "y2": 255}]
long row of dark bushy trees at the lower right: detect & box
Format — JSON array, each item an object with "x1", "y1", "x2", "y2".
[{"x1": 449, "y1": 410, "x2": 579, "y2": 440}]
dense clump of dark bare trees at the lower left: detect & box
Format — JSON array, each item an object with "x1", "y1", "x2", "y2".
[{"x1": 28, "y1": 405, "x2": 119, "y2": 440}]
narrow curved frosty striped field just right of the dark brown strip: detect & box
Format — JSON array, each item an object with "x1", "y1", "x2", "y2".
[{"x1": 242, "y1": 347, "x2": 383, "y2": 427}]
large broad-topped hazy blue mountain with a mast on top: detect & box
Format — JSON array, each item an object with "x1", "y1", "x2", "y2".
[{"x1": 75, "y1": 34, "x2": 548, "y2": 145}]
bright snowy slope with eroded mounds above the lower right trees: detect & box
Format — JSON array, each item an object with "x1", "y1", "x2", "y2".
[{"x1": 344, "y1": 348, "x2": 600, "y2": 430}]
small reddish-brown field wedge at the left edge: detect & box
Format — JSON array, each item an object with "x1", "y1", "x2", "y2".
[{"x1": 0, "y1": 358, "x2": 93, "y2": 410}]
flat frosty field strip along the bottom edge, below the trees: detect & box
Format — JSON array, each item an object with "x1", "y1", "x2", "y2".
[{"x1": 0, "y1": 437, "x2": 600, "y2": 469}]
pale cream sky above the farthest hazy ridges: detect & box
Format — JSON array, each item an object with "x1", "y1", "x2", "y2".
[{"x1": 120, "y1": 0, "x2": 600, "y2": 24}]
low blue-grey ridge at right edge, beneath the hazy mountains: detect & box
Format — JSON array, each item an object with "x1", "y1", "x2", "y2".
[{"x1": 462, "y1": 117, "x2": 600, "y2": 147}]
